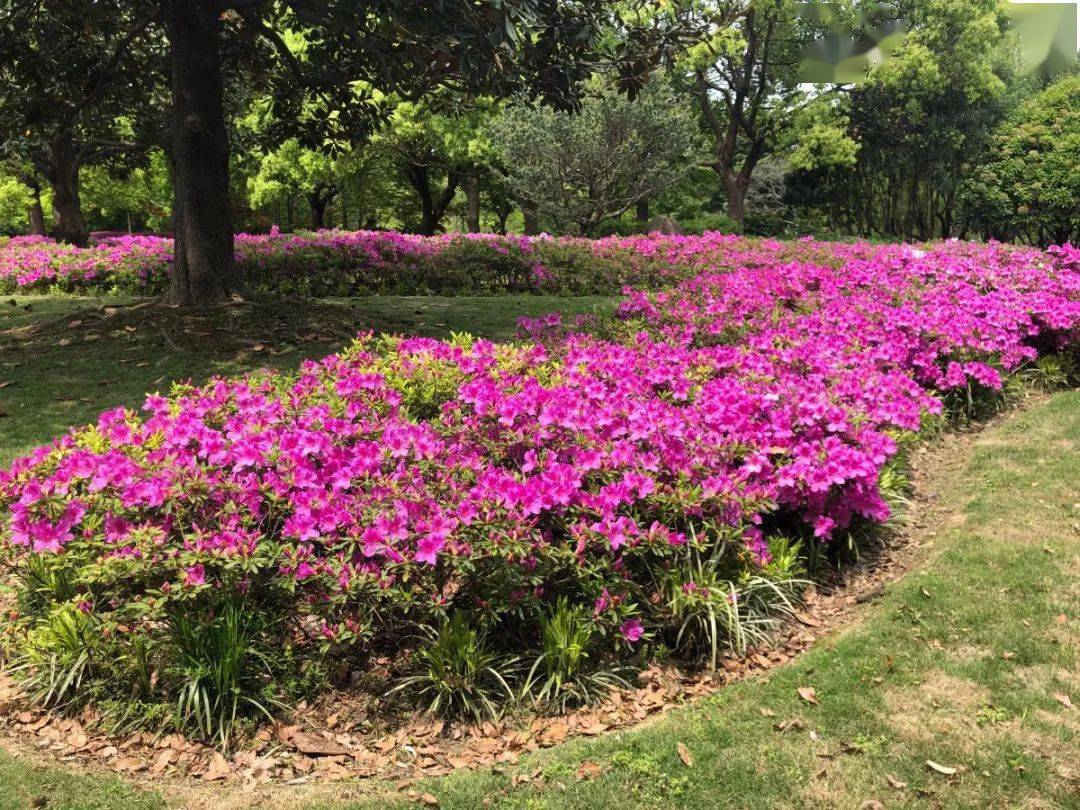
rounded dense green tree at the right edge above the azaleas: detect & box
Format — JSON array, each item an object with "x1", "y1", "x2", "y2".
[{"x1": 962, "y1": 73, "x2": 1080, "y2": 246}]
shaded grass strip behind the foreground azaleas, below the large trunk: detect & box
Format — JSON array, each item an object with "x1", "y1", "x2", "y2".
[{"x1": 0, "y1": 295, "x2": 615, "y2": 463}]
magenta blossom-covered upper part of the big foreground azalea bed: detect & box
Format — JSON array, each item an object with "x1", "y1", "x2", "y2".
[{"x1": 0, "y1": 238, "x2": 1080, "y2": 640}]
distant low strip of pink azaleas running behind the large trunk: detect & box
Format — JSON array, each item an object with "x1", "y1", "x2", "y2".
[{"x1": 0, "y1": 230, "x2": 842, "y2": 296}]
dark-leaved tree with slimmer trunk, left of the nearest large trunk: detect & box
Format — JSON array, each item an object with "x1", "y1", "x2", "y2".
[{"x1": 0, "y1": 0, "x2": 160, "y2": 244}]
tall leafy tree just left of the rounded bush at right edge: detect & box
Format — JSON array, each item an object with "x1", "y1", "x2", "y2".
[{"x1": 793, "y1": 0, "x2": 1025, "y2": 239}]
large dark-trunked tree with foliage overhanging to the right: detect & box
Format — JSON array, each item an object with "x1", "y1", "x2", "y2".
[{"x1": 159, "y1": 0, "x2": 639, "y2": 305}]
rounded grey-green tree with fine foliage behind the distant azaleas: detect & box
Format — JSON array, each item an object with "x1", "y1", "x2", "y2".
[{"x1": 492, "y1": 79, "x2": 698, "y2": 235}]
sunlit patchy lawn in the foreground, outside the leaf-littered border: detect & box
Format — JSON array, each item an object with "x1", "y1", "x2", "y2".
[{"x1": 0, "y1": 391, "x2": 1080, "y2": 808}]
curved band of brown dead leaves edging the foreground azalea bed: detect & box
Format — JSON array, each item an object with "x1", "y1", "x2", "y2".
[{"x1": 0, "y1": 412, "x2": 989, "y2": 804}]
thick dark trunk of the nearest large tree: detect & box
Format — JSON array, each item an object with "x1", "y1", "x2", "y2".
[{"x1": 165, "y1": 0, "x2": 242, "y2": 307}]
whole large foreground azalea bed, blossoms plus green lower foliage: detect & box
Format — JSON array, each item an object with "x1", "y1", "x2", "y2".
[{"x1": 0, "y1": 238, "x2": 1080, "y2": 743}]
